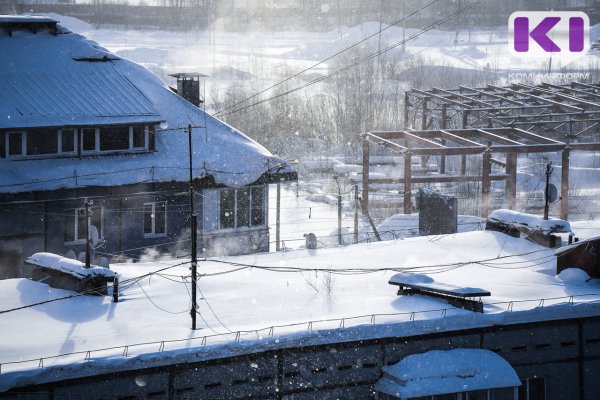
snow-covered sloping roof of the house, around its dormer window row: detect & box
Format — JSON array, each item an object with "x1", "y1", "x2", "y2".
[{"x1": 0, "y1": 18, "x2": 294, "y2": 193}]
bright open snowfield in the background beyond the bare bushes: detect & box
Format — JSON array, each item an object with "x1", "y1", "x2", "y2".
[{"x1": 39, "y1": 14, "x2": 600, "y2": 111}]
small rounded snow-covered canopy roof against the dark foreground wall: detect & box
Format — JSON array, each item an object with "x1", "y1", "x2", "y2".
[{"x1": 375, "y1": 349, "x2": 521, "y2": 399}]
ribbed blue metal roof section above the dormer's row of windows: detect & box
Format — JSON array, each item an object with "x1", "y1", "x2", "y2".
[{"x1": 0, "y1": 30, "x2": 161, "y2": 128}]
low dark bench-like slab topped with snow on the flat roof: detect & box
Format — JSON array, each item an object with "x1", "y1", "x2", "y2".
[{"x1": 388, "y1": 273, "x2": 491, "y2": 313}]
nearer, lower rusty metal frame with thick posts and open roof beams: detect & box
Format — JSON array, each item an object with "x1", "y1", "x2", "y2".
[{"x1": 362, "y1": 128, "x2": 600, "y2": 219}]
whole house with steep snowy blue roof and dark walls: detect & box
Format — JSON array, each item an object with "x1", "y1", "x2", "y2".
[{"x1": 0, "y1": 16, "x2": 295, "y2": 278}]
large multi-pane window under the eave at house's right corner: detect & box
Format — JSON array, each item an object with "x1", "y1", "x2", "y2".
[{"x1": 219, "y1": 186, "x2": 265, "y2": 229}]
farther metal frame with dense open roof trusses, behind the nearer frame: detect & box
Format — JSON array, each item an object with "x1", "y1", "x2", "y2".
[{"x1": 404, "y1": 82, "x2": 600, "y2": 142}]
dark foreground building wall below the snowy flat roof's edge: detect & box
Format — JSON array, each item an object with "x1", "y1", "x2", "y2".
[{"x1": 0, "y1": 317, "x2": 600, "y2": 400}]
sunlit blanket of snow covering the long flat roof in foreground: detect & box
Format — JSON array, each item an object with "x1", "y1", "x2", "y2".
[{"x1": 0, "y1": 227, "x2": 600, "y2": 390}]
